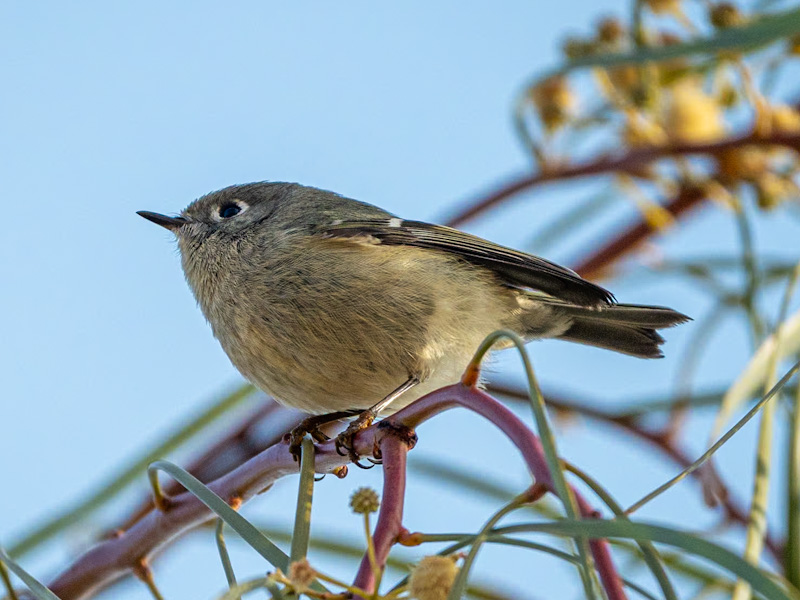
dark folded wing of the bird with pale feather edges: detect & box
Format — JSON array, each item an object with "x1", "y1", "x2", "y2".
[{"x1": 315, "y1": 218, "x2": 614, "y2": 307}]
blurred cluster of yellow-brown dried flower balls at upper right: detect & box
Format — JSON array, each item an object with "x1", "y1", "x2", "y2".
[{"x1": 518, "y1": 0, "x2": 800, "y2": 209}]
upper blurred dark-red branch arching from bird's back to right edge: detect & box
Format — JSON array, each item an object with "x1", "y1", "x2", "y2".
[{"x1": 447, "y1": 133, "x2": 800, "y2": 227}]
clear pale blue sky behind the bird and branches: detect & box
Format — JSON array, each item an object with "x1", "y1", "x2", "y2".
[{"x1": 0, "y1": 0, "x2": 796, "y2": 600}]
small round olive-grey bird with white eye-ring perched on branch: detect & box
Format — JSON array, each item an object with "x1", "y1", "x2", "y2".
[{"x1": 138, "y1": 182, "x2": 688, "y2": 460}]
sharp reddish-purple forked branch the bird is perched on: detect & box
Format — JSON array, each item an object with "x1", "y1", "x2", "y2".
[{"x1": 50, "y1": 384, "x2": 625, "y2": 600}]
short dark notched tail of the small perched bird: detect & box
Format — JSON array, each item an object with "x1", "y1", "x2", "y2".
[{"x1": 558, "y1": 303, "x2": 691, "y2": 358}]
